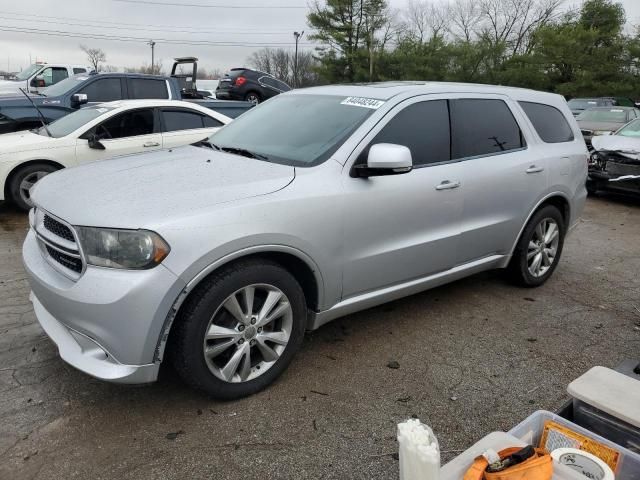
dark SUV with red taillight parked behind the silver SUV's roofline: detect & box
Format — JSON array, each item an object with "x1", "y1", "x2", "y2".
[{"x1": 216, "y1": 68, "x2": 291, "y2": 103}]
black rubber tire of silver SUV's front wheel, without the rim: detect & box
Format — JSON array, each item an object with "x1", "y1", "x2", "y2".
[{"x1": 168, "y1": 259, "x2": 307, "y2": 400}]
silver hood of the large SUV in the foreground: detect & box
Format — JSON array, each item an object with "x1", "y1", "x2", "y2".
[{"x1": 31, "y1": 146, "x2": 295, "y2": 229}]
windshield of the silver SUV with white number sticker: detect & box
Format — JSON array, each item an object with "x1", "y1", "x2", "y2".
[{"x1": 209, "y1": 95, "x2": 383, "y2": 167}]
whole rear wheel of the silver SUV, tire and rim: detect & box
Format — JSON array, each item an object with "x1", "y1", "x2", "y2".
[{"x1": 509, "y1": 205, "x2": 566, "y2": 287}]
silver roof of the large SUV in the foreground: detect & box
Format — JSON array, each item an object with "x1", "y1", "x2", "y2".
[{"x1": 287, "y1": 81, "x2": 565, "y2": 103}]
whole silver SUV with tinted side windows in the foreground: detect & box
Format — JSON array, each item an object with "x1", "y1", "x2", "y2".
[{"x1": 23, "y1": 83, "x2": 587, "y2": 399}]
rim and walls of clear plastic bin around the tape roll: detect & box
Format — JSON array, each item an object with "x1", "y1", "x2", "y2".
[{"x1": 509, "y1": 410, "x2": 640, "y2": 480}]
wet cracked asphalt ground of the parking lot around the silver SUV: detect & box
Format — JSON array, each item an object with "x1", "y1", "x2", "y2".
[{"x1": 0, "y1": 196, "x2": 640, "y2": 480}]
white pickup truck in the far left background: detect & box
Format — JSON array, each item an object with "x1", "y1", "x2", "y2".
[{"x1": 0, "y1": 63, "x2": 93, "y2": 95}]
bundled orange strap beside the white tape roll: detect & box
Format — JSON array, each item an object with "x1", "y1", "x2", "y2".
[{"x1": 463, "y1": 447, "x2": 553, "y2": 480}]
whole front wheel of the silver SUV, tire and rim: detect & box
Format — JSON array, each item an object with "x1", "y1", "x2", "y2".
[{"x1": 169, "y1": 260, "x2": 306, "y2": 400}]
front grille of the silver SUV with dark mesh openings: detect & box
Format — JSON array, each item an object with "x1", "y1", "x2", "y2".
[{"x1": 32, "y1": 208, "x2": 85, "y2": 280}]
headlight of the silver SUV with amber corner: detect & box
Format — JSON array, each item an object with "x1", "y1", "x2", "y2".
[{"x1": 77, "y1": 227, "x2": 171, "y2": 270}]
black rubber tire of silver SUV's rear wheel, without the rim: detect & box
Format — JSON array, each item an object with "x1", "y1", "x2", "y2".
[{"x1": 508, "y1": 205, "x2": 566, "y2": 288}]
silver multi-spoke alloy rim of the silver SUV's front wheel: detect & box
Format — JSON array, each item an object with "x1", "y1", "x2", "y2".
[{"x1": 203, "y1": 284, "x2": 293, "y2": 383}]
